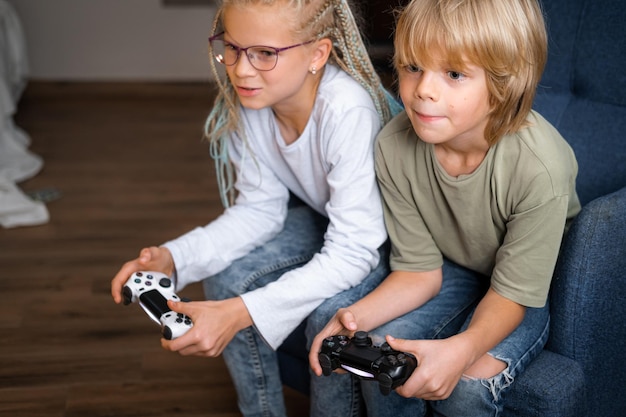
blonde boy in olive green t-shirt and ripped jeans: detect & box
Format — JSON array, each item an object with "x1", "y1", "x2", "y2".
[{"x1": 310, "y1": 0, "x2": 580, "y2": 417}]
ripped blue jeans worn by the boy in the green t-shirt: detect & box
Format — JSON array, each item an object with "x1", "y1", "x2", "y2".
[{"x1": 307, "y1": 261, "x2": 549, "y2": 417}]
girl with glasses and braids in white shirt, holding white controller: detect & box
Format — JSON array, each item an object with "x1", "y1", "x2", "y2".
[{"x1": 112, "y1": 0, "x2": 394, "y2": 416}]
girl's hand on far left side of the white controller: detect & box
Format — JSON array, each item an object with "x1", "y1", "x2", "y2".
[{"x1": 111, "y1": 246, "x2": 174, "y2": 304}]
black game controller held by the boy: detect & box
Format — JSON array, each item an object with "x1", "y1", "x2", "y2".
[{"x1": 318, "y1": 331, "x2": 417, "y2": 395}]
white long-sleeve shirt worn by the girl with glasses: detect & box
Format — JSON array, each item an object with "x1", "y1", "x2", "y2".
[{"x1": 164, "y1": 65, "x2": 387, "y2": 349}]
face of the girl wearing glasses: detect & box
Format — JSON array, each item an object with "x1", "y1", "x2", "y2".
[{"x1": 223, "y1": 5, "x2": 319, "y2": 109}]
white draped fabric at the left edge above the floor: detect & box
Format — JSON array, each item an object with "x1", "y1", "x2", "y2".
[{"x1": 0, "y1": 0, "x2": 49, "y2": 228}]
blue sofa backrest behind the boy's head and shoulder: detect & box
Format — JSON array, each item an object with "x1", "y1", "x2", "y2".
[{"x1": 534, "y1": 0, "x2": 626, "y2": 204}]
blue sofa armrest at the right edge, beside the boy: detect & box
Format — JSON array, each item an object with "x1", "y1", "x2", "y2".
[{"x1": 547, "y1": 187, "x2": 626, "y2": 416}]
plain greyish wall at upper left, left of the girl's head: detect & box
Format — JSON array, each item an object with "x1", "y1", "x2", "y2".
[{"x1": 7, "y1": 0, "x2": 215, "y2": 81}]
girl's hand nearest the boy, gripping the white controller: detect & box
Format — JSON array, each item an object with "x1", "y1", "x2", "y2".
[{"x1": 161, "y1": 297, "x2": 252, "y2": 357}]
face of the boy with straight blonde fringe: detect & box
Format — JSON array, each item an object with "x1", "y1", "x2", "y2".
[{"x1": 398, "y1": 53, "x2": 491, "y2": 149}]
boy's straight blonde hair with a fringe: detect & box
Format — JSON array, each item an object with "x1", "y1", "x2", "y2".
[{"x1": 394, "y1": 0, "x2": 547, "y2": 145}]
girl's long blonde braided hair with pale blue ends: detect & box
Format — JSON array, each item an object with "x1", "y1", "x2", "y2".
[{"x1": 204, "y1": 0, "x2": 398, "y2": 207}]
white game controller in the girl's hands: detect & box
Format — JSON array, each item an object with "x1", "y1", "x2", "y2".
[{"x1": 122, "y1": 271, "x2": 193, "y2": 340}]
